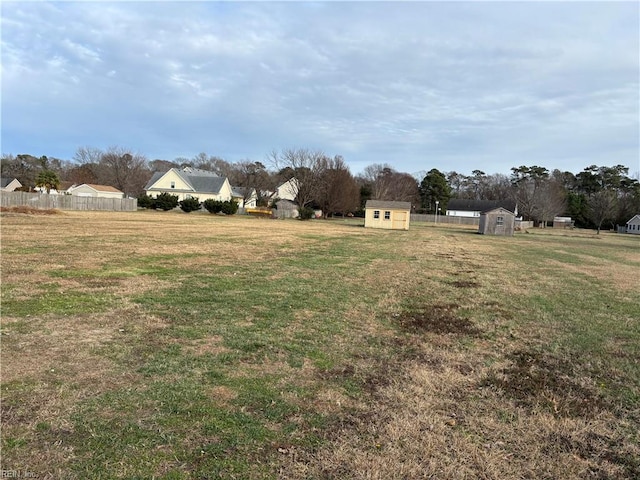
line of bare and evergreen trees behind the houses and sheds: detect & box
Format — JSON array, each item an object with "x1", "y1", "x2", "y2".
[{"x1": 0, "y1": 147, "x2": 640, "y2": 230}]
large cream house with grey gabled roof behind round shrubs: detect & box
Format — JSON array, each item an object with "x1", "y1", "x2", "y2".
[{"x1": 144, "y1": 167, "x2": 233, "y2": 202}]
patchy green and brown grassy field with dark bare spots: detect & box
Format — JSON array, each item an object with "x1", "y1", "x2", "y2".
[{"x1": 0, "y1": 212, "x2": 640, "y2": 480}]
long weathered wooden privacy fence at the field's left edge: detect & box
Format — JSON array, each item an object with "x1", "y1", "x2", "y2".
[{"x1": 0, "y1": 192, "x2": 138, "y2": 212}]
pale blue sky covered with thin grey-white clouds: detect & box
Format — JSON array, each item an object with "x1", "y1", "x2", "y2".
[{"x1": 0, "y1": 1, "x2": 640, "y2": 175}]
